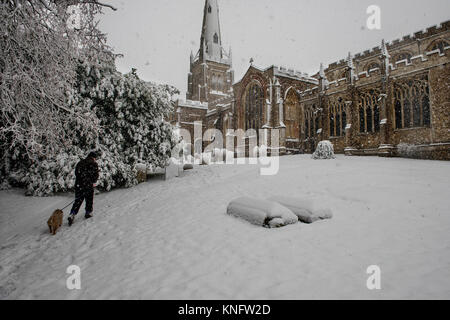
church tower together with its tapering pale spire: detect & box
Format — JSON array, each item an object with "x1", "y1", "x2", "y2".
[{"x1": 186, "y1": 0, "x2": 234, "y2": 103}]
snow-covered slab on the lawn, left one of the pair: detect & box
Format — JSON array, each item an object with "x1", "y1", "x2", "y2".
[{"x1": 227, "y1": 197, "x2": 298, "y2": 228}]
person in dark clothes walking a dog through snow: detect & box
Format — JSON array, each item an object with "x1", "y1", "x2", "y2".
[{"x1": 68, "y1": 152, "x2": 99, "y2": 226}]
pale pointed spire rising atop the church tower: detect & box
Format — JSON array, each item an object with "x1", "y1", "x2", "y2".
[{"x1": 200, "y1": 0, "x2": 223, "y2": 62}]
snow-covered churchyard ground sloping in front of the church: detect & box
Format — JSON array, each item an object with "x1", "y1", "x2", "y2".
[{"x1": 0, "y1": 156, "x2": 450, "y2": 299}]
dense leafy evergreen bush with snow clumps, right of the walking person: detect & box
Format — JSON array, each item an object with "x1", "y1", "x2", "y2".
[{"x1": 77, "y1": 64, "x2": 178, "y2": 190}]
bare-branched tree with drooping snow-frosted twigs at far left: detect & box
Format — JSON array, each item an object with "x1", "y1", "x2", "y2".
[{"x1": 0, "y1": 0, "x2": 113, "y2": 165}]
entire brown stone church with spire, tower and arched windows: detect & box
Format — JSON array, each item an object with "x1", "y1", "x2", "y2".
[{"x1": 171, "y1": 0, "x2": 450, "y2": 160}]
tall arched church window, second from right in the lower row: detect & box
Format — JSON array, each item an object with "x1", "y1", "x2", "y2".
[{"x1": 358, "y1": 90, "x2": 380, "y2": 133}]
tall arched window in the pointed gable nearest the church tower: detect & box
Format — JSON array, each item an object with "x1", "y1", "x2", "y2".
[{"x1": 245, "y1": 83, "x2": 264, "y2": 130}]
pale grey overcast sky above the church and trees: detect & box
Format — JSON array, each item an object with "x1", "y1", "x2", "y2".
[{"x1": 100, "y1": 0, "x2": 450, "y2": 96}]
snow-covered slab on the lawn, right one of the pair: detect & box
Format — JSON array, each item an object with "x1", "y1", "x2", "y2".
[{"x1": 270, "y1": 197, "x2": 333, "y2": 223}]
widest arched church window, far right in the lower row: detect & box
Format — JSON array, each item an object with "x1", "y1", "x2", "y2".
[{"x1": 393, "y1": 75, "x2": 431, "y2": 129}]
